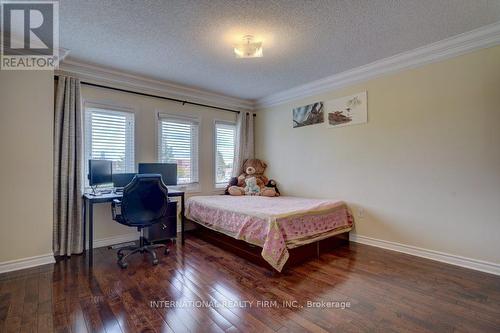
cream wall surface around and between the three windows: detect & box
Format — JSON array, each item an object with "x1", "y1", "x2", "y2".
[{"x1": 82, "y1": 85, "x2": 236, "y2": 240}]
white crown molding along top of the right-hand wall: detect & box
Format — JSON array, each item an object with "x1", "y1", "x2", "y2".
[{"x1": 255, "y1": 22, "x2": 500, "y2": 109}]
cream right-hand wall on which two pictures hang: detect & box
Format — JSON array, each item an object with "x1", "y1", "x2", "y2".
[{"x1": 256, "y1": 47, "x2": 500, "y2": 263}]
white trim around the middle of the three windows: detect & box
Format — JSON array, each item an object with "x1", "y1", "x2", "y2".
[{"x1": 155, "y1": 110, "x2": 202, "y2": 193}]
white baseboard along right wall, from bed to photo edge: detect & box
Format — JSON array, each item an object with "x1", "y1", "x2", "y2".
[{"x1": 349, "y1": 233, "x2": 500, "y2": 275}]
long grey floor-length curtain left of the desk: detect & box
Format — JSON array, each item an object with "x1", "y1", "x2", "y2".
[{"x1": 52, "y1": 76, "x2": 84, "y2": 256}]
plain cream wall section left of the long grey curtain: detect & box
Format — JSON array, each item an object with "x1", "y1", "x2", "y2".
[{"x1": 0, "y1": 70, "x2": 54, "y2": 263}]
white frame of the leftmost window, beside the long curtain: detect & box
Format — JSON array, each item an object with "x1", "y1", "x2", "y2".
[{"x1": 82, "y1": 100, "x2": 137, "y2": 189}]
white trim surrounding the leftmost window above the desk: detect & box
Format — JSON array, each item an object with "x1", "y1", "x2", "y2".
[{"x1": 82, "y1": 99, "x2": 137, "y2": 190}]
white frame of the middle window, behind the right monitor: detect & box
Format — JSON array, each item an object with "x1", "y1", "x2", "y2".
[{"x1": 156, "y1": 110, "x2": 202, "y2": 189}]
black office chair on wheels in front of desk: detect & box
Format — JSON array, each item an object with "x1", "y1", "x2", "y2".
[{"x1": 111, "y1": 174, "x2": 168, "y2": 268}]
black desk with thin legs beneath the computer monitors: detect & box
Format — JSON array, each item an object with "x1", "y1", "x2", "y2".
[{"x1": 83, "y1": 189, "x2": 184, "y2": 265}]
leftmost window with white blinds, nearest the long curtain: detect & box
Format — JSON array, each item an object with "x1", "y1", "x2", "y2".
[{"x1": 85, "y1": 107, "x2": 135, "y2": 179}]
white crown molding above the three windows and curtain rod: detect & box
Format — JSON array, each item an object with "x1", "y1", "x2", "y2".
[{"x1": 56, "y1": 59, "x2": 254, "y2": 111}]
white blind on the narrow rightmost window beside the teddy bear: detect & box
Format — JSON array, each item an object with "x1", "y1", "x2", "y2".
[{"x1": 215, "y1": 121, "x2": 236, "y2": 185}]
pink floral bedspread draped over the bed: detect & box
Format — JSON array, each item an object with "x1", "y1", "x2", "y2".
[{"x1": 186, "y1": 195, "x2": 353, "y2": 272}]
